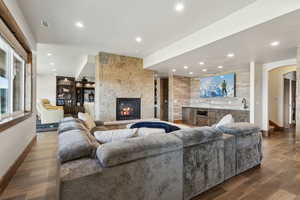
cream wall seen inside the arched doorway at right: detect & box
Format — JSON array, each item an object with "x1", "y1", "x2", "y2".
[{"x1": 269, "y1": 66, "x2": 296, "y2": 127}]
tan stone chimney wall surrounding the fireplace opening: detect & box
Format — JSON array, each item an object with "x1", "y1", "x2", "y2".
[{"x1": 95, "y1": 52, "x2": 154, "y2": 121}]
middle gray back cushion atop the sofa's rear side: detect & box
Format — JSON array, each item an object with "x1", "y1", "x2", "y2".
[{"x1": 172, "y1": 126, "x2": 222, "y2": 147}]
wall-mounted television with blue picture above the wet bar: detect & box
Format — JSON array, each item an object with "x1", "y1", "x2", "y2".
[{"x1": 200, "y1": 73, "x2": 236, "y2": 98}]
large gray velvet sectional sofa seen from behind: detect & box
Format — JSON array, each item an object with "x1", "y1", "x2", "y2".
[{"x1": 58, "y1": 119, "x2": 262, "y2": 200}]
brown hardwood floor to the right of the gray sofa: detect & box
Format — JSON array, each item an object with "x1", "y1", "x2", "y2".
[{"x1": 193, "y1": 130, "x2": 300, "y2": 200}]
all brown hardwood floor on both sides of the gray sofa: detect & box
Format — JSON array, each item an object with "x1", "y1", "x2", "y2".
[{"x1": 0, "y1": 131, "x2": 300, "y2": 200}]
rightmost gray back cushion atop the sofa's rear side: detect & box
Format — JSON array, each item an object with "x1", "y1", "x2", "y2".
[{"x1": 218, "y1": 122, "x2": 260, "y2": 135}]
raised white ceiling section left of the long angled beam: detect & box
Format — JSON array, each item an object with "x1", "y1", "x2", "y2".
[{"x1": 18, "y1": 0, "x2": 255, "y2": 76}]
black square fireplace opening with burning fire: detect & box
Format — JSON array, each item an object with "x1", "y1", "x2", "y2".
[{"x1": 116, "y1": 98, "x2": 141, "y2": 120}]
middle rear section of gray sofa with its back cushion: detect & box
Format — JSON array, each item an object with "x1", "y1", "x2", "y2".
[{"x1": 173, "y1": 127, "x2": 224, "y2": 200}]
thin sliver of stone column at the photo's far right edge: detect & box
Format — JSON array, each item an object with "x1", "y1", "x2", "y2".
[{"x1": 296, "y1": 47, "x2": 300, "y2": 142}]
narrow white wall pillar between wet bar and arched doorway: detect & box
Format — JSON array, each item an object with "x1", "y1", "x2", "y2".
[{"x1": 249, "y1": 62, "x2": 263, "y2": 127}]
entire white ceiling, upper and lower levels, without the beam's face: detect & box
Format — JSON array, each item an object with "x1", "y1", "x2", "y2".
[{"x1": 18, "y1": 0, "x2": 300, "y2": 76}]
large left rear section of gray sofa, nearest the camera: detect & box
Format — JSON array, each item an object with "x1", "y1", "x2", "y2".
[{"x1": 61, "y1": 134, "x2": 183, "y2": 200}]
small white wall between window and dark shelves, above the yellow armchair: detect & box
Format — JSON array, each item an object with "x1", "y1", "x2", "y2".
[{"x1": 36, "y1": 74, "x2": 56, "y2": 105}]
